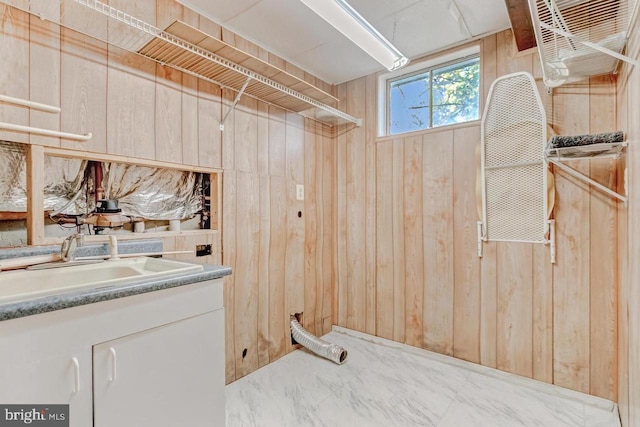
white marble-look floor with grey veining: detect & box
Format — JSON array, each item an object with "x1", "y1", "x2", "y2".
[{"x1": 226, "y1": 329, "x2": 619, "y2": 427}]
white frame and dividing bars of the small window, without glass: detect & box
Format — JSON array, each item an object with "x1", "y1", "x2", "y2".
[{"x1": 377, "y1": 44, "x2": 482, "y2": 138}]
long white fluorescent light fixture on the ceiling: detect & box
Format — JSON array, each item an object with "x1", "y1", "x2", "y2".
[{"x1": 300, "y1": 0, "x2": 409, "y2": 71}]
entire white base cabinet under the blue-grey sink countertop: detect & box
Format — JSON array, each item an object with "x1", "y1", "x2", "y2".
[{"x1": 0, "y1": 279, "x2": 225, "y2": 427}]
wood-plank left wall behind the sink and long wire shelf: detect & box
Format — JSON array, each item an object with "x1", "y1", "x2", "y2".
[{"x1": 0, "y1": 0, "x2": 336, "y2": 382}]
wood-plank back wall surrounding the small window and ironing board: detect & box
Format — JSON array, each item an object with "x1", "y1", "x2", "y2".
[{"x1": 334, "y1": 30, "x2": 619, "y2": 400}]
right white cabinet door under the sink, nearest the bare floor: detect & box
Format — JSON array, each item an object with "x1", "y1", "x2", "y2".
[{"x1": 93, "y1": 310, "x2": 225, "y2": 427}]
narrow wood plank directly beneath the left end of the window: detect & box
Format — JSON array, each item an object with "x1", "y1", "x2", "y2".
[{"x1": 376, "y1": 141, "x2": 396, "y2": 339}]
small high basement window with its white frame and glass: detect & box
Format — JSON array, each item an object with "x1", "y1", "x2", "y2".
[{"x1": 378, "y1": 46, "x2": 480, "y2": 136}]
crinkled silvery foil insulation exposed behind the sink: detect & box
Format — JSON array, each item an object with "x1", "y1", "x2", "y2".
[{"x1": 0, "y1": 141, "x2": 202, "y2": 220}]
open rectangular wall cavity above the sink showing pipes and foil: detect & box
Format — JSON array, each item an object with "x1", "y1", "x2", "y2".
[{"x1": 0, "y1": 142, "x2": 218, "y2": 246}]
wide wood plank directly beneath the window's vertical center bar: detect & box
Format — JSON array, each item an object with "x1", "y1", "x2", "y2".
[{"x1": 422, "y1": 131, "x2": 454, "y2": 355}]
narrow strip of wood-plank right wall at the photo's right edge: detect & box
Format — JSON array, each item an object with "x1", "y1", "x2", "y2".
[{"x1": 617, "y1": 10, "x2": 640, "y2": 427}]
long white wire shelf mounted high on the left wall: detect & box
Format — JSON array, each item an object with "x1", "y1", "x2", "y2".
[{"x1": 5, "y1": 0, "x2": 362, "y2": 129}]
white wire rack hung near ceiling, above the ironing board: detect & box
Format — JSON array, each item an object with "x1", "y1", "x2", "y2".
[{"x1": 529, "y1": 0, "x2": 637, "y2": 87}]
